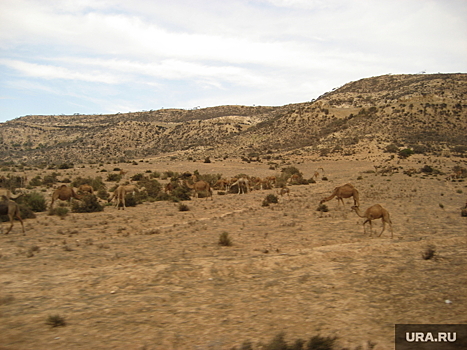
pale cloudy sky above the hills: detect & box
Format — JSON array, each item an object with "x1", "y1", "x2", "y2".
[{"x1": 0, "y1": 0, "x2": 467, "y2": 122}]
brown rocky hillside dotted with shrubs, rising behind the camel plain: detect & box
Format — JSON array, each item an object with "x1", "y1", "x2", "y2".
[{"x1": 0, "y1": 74, "x2": 467, "y2": 163}]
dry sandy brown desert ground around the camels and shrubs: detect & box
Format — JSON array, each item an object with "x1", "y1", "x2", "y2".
[{"x1": 0, "y1": 155, "x2": 467, "y2": 350}]
